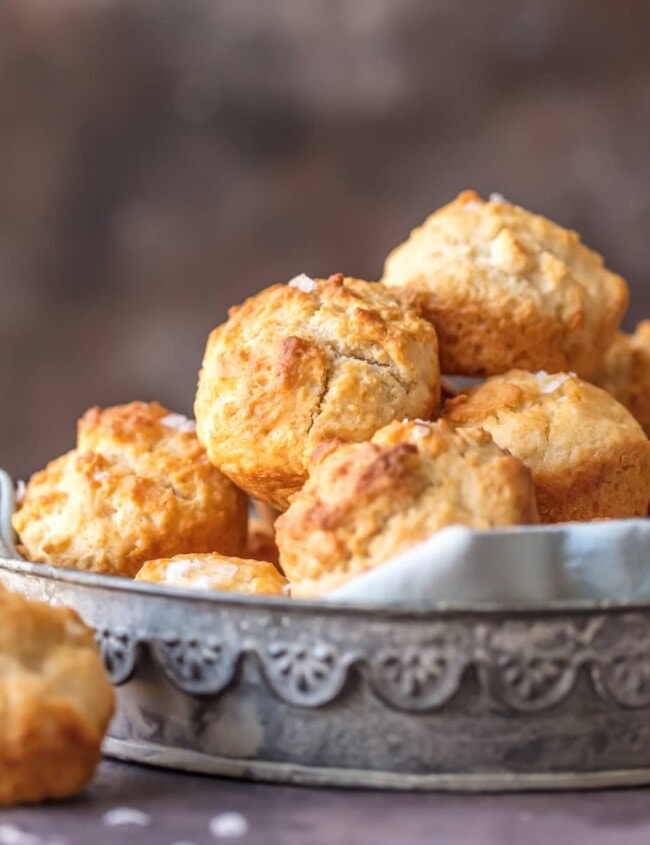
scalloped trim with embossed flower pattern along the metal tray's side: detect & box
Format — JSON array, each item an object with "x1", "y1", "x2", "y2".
[{"x1": 102, "y1": 617, "x2": 650, "y2": 713}]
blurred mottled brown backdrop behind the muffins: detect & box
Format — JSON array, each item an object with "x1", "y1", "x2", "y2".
[{"x1": 0, "y1": 0, "x2": 650, "y2": 477}]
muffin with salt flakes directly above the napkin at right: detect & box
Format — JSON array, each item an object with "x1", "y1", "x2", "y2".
[{"x1": 444, "y1": 370, "x2": 650, "y2": 522}]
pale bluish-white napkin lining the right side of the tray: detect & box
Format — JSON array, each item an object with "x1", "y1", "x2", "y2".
[{"x1": 324, "y1": 519, "x2": 650, "y2": 606}]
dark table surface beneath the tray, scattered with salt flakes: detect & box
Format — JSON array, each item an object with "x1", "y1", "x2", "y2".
[{"x1": 0, "y1": 761, "x2": 650, "y2": 845}]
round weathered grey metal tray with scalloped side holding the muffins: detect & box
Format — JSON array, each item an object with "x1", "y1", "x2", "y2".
[{"x1": 0, "y1": 472, "x2": 650, "y2": 790}]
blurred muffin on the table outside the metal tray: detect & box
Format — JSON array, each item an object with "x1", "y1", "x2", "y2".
[{"x1": 0, "y1": 586, "x2": 114, "y2": 805}]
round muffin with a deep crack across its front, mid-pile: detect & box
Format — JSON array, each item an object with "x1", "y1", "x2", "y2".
[{"x1": 194, "y1": 274, "x2": 440, "y2": 510}]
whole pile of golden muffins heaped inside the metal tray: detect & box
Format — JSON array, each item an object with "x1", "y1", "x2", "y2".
[{"x1": 14, "y1": 191, "x2": 650, "y2": 597}]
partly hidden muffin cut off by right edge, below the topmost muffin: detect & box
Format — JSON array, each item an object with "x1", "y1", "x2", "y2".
[{"x1": 597, "y1": 320, "x2": 650, "y2": 437}]
